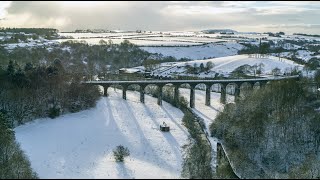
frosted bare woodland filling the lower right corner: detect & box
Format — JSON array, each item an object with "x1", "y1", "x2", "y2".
[{"x1": 210, "y1": 77, "x2": 320, "y2": 178}]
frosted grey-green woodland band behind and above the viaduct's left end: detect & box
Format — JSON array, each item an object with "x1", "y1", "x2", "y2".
[{"x1": 0, "y1": 41, "x2": 150, "y2": 73}]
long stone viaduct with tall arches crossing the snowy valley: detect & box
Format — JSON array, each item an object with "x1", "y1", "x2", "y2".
[{"x1": 82, "y1": 76, "x2": 299, "y2": 108}]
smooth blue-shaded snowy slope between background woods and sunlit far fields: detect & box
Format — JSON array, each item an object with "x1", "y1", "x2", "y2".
[{"x1": 140, "y1": 42, "x2": 243, "y2": 60}]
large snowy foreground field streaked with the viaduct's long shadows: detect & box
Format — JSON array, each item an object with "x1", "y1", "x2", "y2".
[{"x1": 15, "y1": 89, "x2": 189, "y2": 178}]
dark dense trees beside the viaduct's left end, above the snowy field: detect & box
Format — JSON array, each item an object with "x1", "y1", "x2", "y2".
[{"x1": 0, "y1": 59, "x2": 99, "y2": 126}]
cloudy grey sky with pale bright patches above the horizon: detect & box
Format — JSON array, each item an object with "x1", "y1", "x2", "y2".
[{"x1": 0, "y1": 1, "x2": 320, "y2": 34}]
